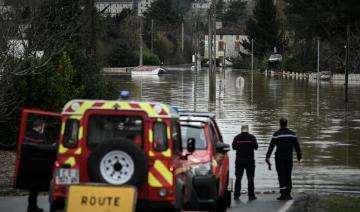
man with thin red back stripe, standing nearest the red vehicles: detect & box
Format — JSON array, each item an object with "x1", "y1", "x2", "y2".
[{"x1": 232, "y1": 125, "x2": 258, "y2": 200}]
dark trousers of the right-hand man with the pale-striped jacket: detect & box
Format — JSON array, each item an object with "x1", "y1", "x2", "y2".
[{"x1": 275, "y1": 158, "x2": 293, "y2": 195}]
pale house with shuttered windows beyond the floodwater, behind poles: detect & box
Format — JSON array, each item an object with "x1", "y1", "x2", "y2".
[{"x1": 204, "y1": 34, "x2": 248, "y2": 61}]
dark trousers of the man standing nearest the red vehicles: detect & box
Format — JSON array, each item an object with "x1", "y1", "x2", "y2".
[{"x1": 234, "y1": 159, "x2": 255, "y2": 197}]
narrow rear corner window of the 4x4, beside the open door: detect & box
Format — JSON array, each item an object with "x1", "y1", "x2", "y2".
[{"x1": 63, "y1": 119, "x2": 80, "y2": 148}]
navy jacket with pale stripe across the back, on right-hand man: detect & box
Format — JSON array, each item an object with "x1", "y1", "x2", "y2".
[{"x1": 266, "y1": 128, "x2": 302, "y2": 160}]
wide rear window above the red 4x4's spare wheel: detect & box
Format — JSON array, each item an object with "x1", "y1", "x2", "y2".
[{"x1": 87, "y1": 115, "x2": 144, "y2": 149}]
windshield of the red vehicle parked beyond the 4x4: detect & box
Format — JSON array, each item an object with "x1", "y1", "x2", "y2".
[{"x1": 181, "y1": 125, "x2": 207, "y2": 150}]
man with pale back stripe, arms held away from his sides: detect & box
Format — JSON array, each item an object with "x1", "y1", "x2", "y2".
[{"x1": 265, "y1": 118, "x2": 302, "y2": 200}]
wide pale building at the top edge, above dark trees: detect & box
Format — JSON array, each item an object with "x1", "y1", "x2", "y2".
[{"x1": 95, "y1": 0, "x2": 133, "y2": 16}]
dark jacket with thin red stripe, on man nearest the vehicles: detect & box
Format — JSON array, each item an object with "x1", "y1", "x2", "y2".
[{"x1": 232, "y1": 132, "x2": 258, "y2": 160}]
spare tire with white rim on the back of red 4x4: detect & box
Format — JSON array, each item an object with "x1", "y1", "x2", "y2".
[{"x1": 88, "y1": 138, "x2": 147, "y2": 186}]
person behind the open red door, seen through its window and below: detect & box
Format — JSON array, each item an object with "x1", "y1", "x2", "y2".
[{"x1": 25, "y1": 119, "x2": 46, "y2": 212}]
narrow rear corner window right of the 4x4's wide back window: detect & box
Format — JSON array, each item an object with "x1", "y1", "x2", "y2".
[{"x1": 153, "y1": 122, "x2": 168, "y2": 152}]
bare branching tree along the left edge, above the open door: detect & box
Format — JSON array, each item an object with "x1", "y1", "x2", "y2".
[{"x1": 0, "y1": 0, "x2": 94, "y2": 148}]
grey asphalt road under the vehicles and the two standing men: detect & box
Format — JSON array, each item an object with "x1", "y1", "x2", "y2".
[{"x1": 0, "y1": 194, "x2": 293, "y2": 212}]
